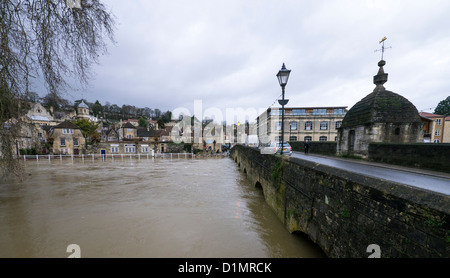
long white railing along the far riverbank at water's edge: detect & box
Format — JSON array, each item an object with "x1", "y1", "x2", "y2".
[{"x1": 18, "y1": 153, "x2": 228, "y2": 161}]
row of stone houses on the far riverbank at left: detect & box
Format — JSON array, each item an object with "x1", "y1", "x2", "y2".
[{"x1": 14, "y1": 101, "x2": 180, "y2": 155}]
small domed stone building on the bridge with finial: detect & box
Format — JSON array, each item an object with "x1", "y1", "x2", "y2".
[{"x1": 337, "y1": 60, "x2": 423, "y2": 157}]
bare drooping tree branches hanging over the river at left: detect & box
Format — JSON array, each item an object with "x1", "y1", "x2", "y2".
[{"x1": 0, "y1": 0, "x2": 114, "y2": 177}]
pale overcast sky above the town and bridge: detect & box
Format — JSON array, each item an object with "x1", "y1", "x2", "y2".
[{"x1": 60, "y1": 0, "x2": 450, "y2": 121}]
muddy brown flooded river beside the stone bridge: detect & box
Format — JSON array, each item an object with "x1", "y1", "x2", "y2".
[{"x1": 0, "y1": 158, "x2": 323, "y2": 258}]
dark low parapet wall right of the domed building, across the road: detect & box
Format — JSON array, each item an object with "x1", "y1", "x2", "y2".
[{"x1": 369, "y1": 143, "x2": 450, "y2": 173}]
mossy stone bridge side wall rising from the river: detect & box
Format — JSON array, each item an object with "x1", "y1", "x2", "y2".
[{"x1": 231, "y1": 146, "x2": 450, "y2": 257}]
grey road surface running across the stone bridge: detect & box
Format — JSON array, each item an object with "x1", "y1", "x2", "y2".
[{"x1": 292, "y1": 152, "x2": 450, "y2": 195}]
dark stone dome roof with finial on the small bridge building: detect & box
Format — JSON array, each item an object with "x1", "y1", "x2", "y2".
[{"x1": 342, "y1": 60, "x2": 421, "y2": 127}]
